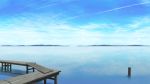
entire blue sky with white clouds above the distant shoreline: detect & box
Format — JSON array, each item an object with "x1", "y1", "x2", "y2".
[{"x1": 0, "y1": 0, "x2": 150, "y2": 45}]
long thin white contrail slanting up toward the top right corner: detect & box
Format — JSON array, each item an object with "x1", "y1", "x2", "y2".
[{"x1": 67, "y1": 2, "x2": 150, "y2": 20}]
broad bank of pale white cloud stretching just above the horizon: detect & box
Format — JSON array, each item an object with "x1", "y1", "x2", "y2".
[{"x1": 0, "y1": 17, "x2": 150, "y2": 45}]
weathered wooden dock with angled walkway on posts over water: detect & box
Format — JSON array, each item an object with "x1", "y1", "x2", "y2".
[{"x1": 0, "y1": 60, "x2": 60, "y2": 84}]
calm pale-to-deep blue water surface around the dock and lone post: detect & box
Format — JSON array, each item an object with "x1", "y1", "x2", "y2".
[{"x1": 0, "y1": 47, "x2": 150, "y2": 84}]
